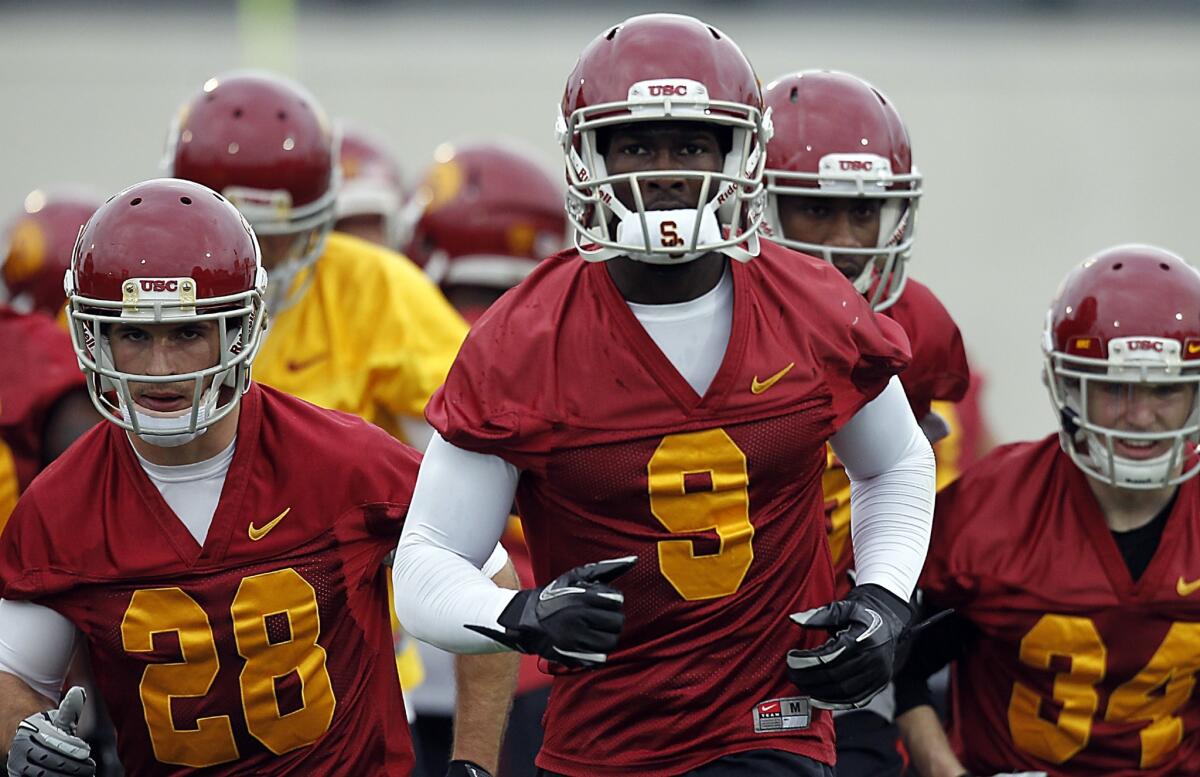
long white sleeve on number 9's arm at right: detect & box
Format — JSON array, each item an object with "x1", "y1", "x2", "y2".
[{"x1": 829, "y1": 378, "x2": 937, "y2": 600}]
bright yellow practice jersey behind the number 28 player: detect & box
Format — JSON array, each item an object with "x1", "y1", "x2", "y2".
[{"x1": 254, "y1": 233, "x2": 467, "y2": 439}]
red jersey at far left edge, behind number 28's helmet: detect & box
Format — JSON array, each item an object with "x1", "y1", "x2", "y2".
[{"x1": 0, "y1": 305, "x2": 83, "y2": 528}]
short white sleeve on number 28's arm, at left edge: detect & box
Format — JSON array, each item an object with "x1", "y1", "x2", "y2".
[{"x1": 0, "y1": 600, "x2": 76, "y2": 701}]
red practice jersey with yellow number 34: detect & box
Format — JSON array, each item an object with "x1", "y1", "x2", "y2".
[{"x1": 922, "y1": 435, "x2": 1200, "y2": 777}]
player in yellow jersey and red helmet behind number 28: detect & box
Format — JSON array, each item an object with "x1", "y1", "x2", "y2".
[{"x1": 159, "y1": 73, "x2": 517, "y2": 769}]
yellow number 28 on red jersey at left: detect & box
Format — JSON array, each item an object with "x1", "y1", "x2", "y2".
[{"x1": 121, "y1": 568, "x2": 337, "y2": 767}]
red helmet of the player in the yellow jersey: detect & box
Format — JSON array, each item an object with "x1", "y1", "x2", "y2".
[{"x1": 164, "y1": 73, "x2": 340, "y2": 311}]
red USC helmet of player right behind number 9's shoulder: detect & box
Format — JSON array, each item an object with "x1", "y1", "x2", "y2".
[{"x1": 763, "y1": 71, "x2": 922, "y2": 311}]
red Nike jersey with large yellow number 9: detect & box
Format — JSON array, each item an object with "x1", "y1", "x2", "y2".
[{"x1": 426, "y1": 242, "x2": 907, "y2": 777}]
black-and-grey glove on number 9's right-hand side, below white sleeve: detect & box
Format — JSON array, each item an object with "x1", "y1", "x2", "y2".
[{"x1": 787, "y1": 583, "x2": 912, "y2": 710}]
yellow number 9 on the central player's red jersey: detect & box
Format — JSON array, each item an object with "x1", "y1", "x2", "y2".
[{"x1": 647, "y1": 429, "x2": 754, "y2": 601}]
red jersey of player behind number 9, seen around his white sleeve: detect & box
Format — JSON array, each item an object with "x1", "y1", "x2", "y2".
[{"x1": 822, "y1": 278, "x2": 971, "y2": 597}]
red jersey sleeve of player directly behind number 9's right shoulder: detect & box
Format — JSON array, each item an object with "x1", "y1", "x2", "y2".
[{"x1": 883, "y1": 279, "x2": 971, "y2": 420}]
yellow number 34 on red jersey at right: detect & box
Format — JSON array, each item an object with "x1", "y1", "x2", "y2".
[{"x1": 1008, "y1": 614, "x2": 1200, "y2": 769}]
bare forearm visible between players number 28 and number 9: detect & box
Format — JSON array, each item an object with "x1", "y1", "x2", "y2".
[{"x1": 451, "y1": 562, "x2": 521, "y2": 775}]
